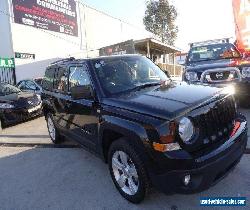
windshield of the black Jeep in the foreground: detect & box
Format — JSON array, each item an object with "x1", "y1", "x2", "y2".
[{"x1": 92, "y1": 56, "x2": 169, "y2": 94}]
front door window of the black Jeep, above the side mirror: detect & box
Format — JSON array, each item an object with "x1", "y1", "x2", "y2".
[{"x1": 69, "y1": 66, "x2": 90, "y2": 88}]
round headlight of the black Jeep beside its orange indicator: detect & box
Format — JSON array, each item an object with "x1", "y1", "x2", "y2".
[{"x1": 179, "y1": 117, "x2": 194, "y2": 143}]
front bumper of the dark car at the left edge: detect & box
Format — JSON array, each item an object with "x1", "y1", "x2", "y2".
[{"x1": 0, "y1": 104, "x2": 42, "y2": 126}]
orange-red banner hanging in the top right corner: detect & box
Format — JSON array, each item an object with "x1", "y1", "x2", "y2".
[{"x1": 233, "y1": 0, "x2": 250, "y2": 53}]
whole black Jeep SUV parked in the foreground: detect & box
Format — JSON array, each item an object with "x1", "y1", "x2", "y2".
[{"x1": 42, "y1": 55, "x2": 247, "y2": 203}]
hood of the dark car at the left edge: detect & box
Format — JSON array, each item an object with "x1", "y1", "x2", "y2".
[{"x1": 0, "y1": 92, "x2": 40, "y2": 108}]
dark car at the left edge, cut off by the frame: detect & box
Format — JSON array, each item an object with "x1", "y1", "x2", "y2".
[{"x1": 0, "y1": 83, "x2": 42, "y2": 129}]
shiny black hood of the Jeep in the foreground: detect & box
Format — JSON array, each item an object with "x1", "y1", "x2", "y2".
[{"x1": 103, "y1": 82, "x2": 222, "y2": 119}]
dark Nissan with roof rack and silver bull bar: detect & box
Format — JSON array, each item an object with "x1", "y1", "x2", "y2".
[{"x1": 183, "y1": 39, "x2": 250, "y2": 107}]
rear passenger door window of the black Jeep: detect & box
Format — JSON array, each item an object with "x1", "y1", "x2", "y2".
[{"x1": 54, "y1": 67, "x2": 68, "y2": 92}]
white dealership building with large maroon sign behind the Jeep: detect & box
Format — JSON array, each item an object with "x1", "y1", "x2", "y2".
[{"x1": 0, "y1": 0, "x2": 179, "y2": 83}]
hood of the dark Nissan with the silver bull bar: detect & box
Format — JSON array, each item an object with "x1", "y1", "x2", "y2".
[{"x1": 186, "y1": 59, "x2": 232, "y2": 72}]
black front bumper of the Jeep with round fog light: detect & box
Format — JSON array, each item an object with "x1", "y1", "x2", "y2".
[{"x1": 151, "y1": 119, "x2": 247, "y2": 194}]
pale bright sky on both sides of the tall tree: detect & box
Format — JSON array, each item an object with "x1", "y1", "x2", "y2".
[{"x1": 82, "y1": 0, "x2": 234, "y2": 50}]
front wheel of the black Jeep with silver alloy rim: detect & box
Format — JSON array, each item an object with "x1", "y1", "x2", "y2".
[{"x1": 108, "y1": 138, "x2": 150, "y2": 203}]
